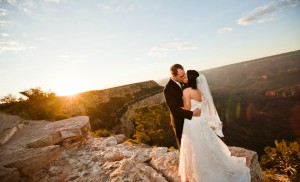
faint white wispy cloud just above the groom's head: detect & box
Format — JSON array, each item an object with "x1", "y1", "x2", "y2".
[{"x1": 148, "y1": 41, "x2": 197, "y2": 56}]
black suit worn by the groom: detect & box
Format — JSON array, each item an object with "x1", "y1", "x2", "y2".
[{"x1": 164, "y1": 79, "x2": 193, "y2": 149}]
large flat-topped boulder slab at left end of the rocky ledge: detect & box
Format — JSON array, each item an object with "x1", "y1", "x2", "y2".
[{"x1": 0, "y1": 114, "x2": 90, "y2": 181}]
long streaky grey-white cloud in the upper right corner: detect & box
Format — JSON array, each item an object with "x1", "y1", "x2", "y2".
[{"x1": 237, "y1": 0, "x2": 300, "y2": 26}]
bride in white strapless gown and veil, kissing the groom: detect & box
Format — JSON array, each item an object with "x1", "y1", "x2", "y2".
[{"x1": 179, "y1": 70, "x2": 251, "y2": 182}]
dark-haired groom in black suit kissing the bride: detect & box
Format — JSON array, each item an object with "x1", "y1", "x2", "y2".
[{"x1": 164, "y1": 64, "x2": 200, "y2": 149}]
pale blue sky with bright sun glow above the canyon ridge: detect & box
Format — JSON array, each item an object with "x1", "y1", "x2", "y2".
[{"x1": 0, "y1": 0, "x2": 300, "y2": 97}]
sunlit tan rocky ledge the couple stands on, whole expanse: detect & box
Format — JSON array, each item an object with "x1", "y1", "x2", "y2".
[{"x1": 0, "y1": 116, "x2": 263, "y2": 182}]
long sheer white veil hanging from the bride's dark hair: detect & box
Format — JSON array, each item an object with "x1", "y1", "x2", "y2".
[{"x1": 197, "y1": 74, "x2": 224, "y2": 137}]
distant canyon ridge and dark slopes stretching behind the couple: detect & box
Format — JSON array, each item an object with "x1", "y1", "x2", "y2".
[{"x1": 61, "y1": 50, "x2": 300, "y2": 155}]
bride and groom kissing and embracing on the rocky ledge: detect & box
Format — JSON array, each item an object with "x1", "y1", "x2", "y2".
[{"x1": 164, "y1": 64, "x2": 251, "y2": 182}]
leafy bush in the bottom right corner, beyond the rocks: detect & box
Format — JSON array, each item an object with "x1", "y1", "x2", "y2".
[{"x1": 261, "y1": 139, "x2": 300, "y2": 178}]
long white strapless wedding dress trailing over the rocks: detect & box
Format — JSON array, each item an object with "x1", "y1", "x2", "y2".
[{"x1": 179, "y1": 99, "x2": 251, "y2": 182}]
